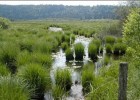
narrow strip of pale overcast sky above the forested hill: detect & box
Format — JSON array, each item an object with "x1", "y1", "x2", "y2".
[{"x1": 0, "y1": 1, "x2": 124, "y2": 6}]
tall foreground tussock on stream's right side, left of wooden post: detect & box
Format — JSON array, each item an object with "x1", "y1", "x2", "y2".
[{"x1": 82, "y1": 65, "x2": 95, "y2": 93}]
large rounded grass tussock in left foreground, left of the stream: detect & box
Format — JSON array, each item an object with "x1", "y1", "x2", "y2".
[{"x1": 17, "y1": 63, "x2": 51, "y2": 98}]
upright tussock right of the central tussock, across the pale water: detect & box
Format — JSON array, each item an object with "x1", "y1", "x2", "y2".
[{"x1": 88, "y1": 43, "x2": 98, "y2": 60}]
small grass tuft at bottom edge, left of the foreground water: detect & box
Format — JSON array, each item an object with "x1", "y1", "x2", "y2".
[{"x1": 52, "y1": 85, "x2": 64, "y2": 100}]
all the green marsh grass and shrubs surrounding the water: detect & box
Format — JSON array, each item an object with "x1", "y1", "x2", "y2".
[{"x1": 0, "y1": 6, "x2": 140, "y2": 100}]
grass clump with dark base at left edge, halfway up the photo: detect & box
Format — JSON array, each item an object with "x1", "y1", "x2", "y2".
[{"x1": 0, "y1": 43, "x2": 19, "y2": 73}]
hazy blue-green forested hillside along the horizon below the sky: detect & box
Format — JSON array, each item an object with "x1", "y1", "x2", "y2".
[{"x1": 0, "y1": 5, "x2": 118, "y2": 20}]
